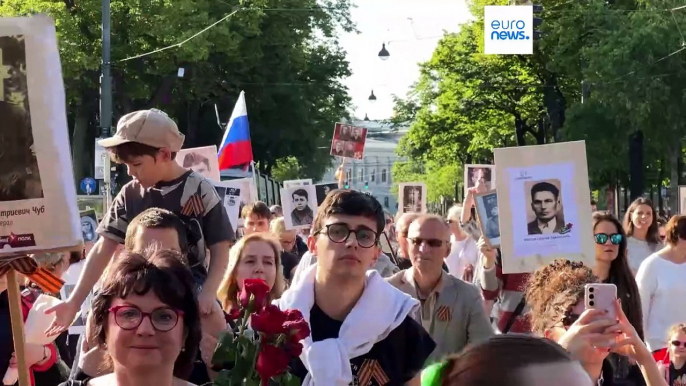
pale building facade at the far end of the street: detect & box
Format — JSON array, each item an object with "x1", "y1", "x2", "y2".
[{"x1": 319, "y1": 120, "x2": 408, "y2": 215}]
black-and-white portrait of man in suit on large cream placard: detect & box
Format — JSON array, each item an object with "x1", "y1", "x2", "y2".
[{"x1": 524, "y1": 179, "x2": 565, "y2": 235}]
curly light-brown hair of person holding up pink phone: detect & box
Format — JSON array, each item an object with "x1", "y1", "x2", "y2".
[{"x1": 524, "y1": 259, "x2": 599, "y2": 334}]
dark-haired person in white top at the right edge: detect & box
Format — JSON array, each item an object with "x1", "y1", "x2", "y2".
[{"x1": 636, "y1": 215, "x2": 686, "y2": 351}]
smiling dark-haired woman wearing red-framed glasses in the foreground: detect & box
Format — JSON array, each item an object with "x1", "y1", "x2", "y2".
[{"x1": 62, "y1": 250, "x2": 200, "y2": 386}]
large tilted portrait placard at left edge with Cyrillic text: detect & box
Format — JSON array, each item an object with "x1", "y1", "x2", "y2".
[{"x1": 0, "y1": 16, "x2": 82, "y2": 253}]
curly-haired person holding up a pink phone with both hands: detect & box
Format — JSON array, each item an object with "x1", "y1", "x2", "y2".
[{"x1": 526, "y1": 259, "x2": 665, "y2": 386}]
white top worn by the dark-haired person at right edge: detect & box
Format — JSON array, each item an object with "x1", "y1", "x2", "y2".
[{"x1": 636, "y1": 253, "x2": 686, "y2": 351}]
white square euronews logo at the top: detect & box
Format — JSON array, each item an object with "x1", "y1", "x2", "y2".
[{"x1": 484, "y1": 5, "x2": 534, "y2": 55}]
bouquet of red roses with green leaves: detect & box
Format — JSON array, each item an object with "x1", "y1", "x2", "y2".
[{"x1": 212, "y1": 279, "x2": 310, "y2": 386}]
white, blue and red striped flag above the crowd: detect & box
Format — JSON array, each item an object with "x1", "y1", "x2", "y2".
[{"x1": 217, "y1": 91, "x2": 253, "y2": 170}]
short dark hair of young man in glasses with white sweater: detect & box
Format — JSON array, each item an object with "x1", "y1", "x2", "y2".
[{"x1": 312, "y1": 189, "x2": 386, "y2": 234}]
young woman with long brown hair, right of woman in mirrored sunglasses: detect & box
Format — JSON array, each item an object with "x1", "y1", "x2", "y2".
[{"x1": 624, "y1": 197, "x2": 662, "y2": 274}]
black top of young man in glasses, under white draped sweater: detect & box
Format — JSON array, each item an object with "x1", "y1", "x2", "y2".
[{"x1": 291, "y1": 304, "x2": 436, "y2": 386}]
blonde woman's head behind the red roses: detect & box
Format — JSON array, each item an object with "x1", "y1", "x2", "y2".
[{"x1": 217, "y1": 233, "x2": 284, "y2": 312}]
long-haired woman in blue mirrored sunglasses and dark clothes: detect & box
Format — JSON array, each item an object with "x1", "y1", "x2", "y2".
[{"x1": 593, "y1": 212, "x2": 644, "y2": 385}]
